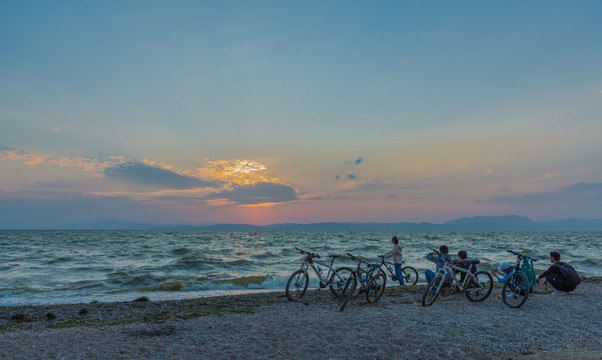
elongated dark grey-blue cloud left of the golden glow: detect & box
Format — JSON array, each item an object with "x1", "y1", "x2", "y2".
[{"x1": 104, "y1": 161, "x2": 217, "y2": 189}]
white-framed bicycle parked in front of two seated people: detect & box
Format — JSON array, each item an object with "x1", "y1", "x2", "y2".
[{"x1": 422, "y1": 250, "x2": 493, "y2": 306}]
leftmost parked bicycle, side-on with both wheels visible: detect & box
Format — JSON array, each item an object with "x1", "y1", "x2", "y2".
[{"x1": 285, "y1": 247, "x2": 349, "y2": 301}]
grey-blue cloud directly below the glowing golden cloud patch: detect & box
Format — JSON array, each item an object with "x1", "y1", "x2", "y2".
[{"x1": 207, "y1": 182, "x2": 298, "y2": 205}]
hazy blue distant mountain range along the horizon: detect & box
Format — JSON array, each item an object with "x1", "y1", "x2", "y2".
[{"x1": 31, "y1": 215, "x2": 602, "y2": 231}]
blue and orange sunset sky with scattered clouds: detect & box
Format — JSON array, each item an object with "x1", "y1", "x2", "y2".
[{"x1": 0, "y1": 0, "x2": 602, "y2": 228}]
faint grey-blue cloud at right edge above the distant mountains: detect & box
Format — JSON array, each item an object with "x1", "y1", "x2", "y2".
[{"x1": 477, "y1": 183, "x2": 602, "y2": 205}]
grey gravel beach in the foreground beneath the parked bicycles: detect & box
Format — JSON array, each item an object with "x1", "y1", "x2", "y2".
[{"x1": 0, "y1": 279, "x2": 602, "y2": 359}]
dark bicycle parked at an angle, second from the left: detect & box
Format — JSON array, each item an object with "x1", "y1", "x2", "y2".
[{"x1": 338, "y1": 253, "x2": 387, "y2": 311}]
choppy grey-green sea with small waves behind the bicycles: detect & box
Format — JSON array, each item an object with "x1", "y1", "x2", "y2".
[{"x1": 0, "y1": 230, "x2": 602, "y2": 306}]
